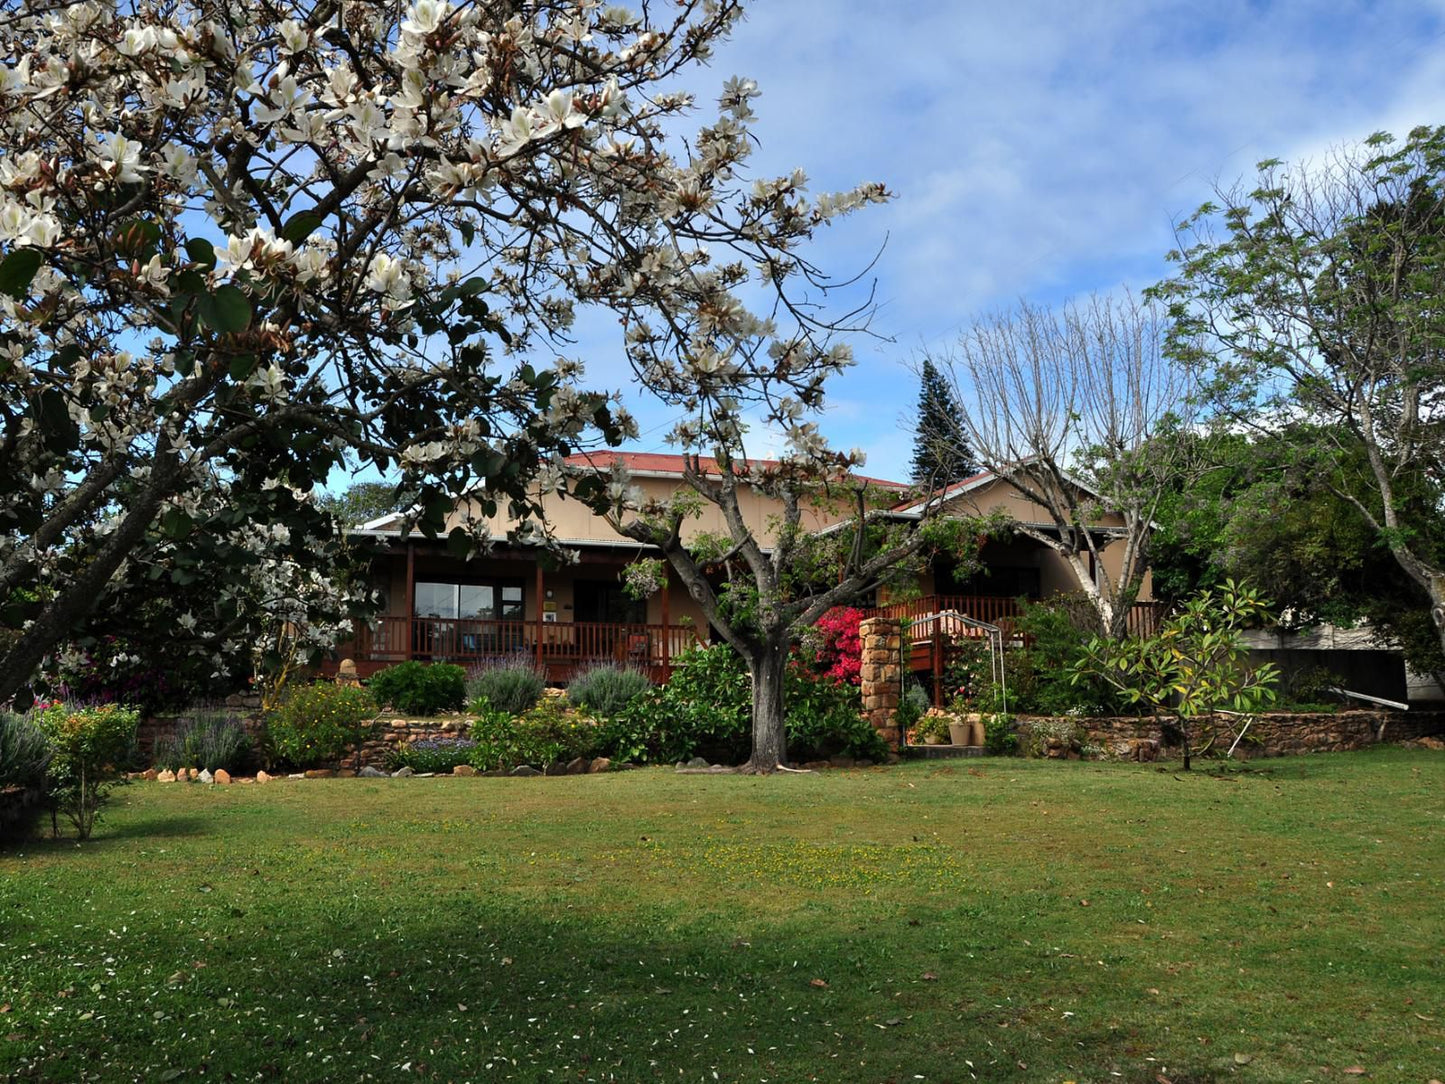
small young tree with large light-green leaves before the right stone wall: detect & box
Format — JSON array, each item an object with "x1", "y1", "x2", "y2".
[{"x1": 1069, "y1": 580, "x2": 1279, "y2": 772}]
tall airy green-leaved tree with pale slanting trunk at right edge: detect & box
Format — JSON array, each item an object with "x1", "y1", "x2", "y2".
[{"x1": 1153, "y1": 127, "x2": 1445, "y2": 661}]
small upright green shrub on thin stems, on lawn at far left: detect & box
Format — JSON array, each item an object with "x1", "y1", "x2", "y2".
[{"x1": 35, "y1": 701, "x2": 140, "y2": 840}]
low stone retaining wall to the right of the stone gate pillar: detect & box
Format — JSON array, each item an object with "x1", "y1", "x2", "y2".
[{"x1": 1019, "y1": 711, "x2": 1445, "y2": 760}]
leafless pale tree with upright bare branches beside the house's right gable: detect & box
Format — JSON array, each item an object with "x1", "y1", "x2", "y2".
[{"x1": 933, "y1": 293, "x2": 1192, "y2": 636}]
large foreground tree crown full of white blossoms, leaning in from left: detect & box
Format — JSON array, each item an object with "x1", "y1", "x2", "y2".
[{"x1": 0, "y1": 0, "x2": 883, "y2": 701}]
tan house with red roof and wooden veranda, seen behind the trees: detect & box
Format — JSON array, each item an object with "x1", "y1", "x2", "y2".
[{"x1": 330, "y1": 452, "x2": 1161, "y2": 682}]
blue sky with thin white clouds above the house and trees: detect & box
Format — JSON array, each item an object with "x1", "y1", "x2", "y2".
[{"x1": 579, "y1": 0, "x2": 1445, "y2": 478}]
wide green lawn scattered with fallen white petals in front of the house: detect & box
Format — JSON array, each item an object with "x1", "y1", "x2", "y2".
[{"x1": 0, "y1": 749, "x2": 1445, "y2": 1084}]
